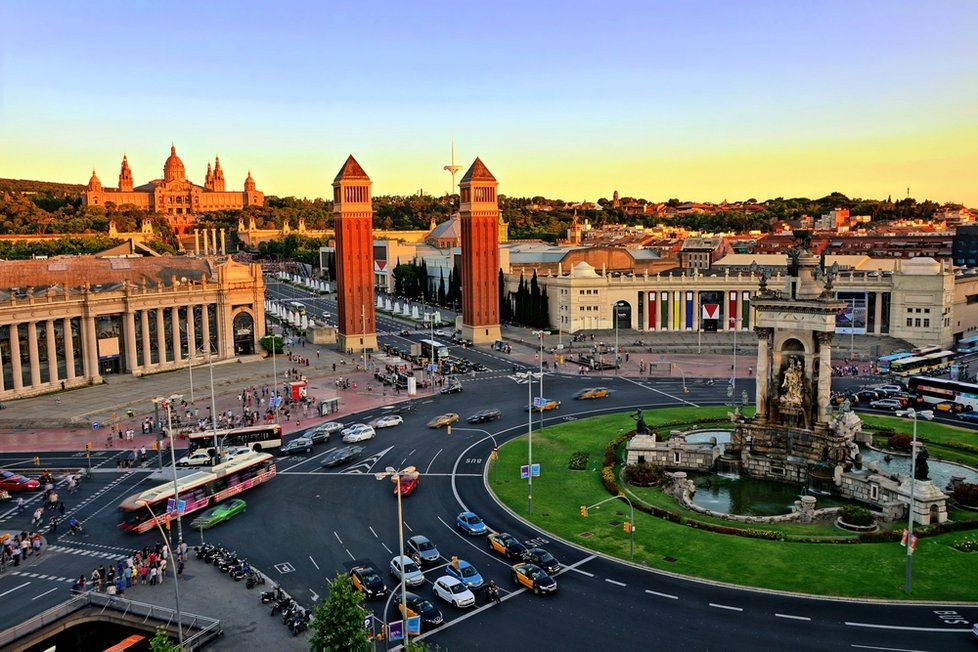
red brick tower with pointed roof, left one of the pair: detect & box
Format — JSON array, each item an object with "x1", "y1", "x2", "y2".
[{"x1": 333, "y1": 156, "x2": 377, "y2": 353}]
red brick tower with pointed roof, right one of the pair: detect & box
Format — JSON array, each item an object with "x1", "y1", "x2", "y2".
[{"x1": 458, "y1": 159, "x2": 500, "y2": 344}]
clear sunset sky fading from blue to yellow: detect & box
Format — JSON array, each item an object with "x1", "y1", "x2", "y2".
[{"x1": 0, "y1": 0, "x2": 978, "y2": 207}]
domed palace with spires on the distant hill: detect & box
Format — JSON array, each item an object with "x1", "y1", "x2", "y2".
[{"x1": 82, "y1": 146, "x2": 265, "y2": 228}]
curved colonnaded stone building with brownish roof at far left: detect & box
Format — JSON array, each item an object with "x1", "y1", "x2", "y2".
[{"x1": 0, "y1": 256, "x2": 265, "y2": 400}]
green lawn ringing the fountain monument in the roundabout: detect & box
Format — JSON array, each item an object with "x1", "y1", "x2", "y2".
[{"x1": 489, "y1": 408, "x2": 978, "y2": 601}]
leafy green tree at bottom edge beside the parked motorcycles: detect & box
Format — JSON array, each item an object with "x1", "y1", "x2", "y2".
[{"x1": 309, "y1": 573, "x2": 368, "y2": 652}]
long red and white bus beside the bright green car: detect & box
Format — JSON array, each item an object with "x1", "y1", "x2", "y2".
[{"x1": 119, "y1": 452, "x2": 276, "y2": 533}]
